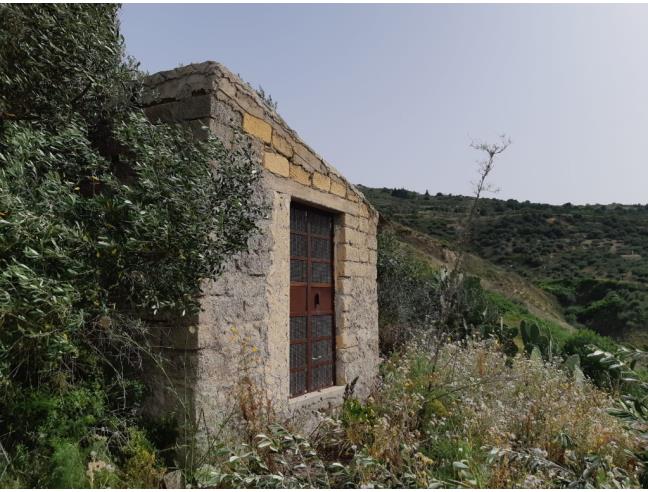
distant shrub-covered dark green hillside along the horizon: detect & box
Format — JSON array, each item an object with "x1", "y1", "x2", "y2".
[{"x1": 361, "y1": 187, "x2": 648, "y2": 344}]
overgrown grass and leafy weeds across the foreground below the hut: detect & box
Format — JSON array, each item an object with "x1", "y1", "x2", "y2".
[{"x1": 193, "y1": 340, "x2": 645, "y2": 488}]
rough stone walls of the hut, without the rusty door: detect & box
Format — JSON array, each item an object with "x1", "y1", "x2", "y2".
[{"x1": 140, "y1": 62, "x2": 378, "y2": 434}]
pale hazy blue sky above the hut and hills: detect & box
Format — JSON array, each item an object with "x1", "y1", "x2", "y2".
[{"x1": 120, "y1": 4, "x2": 648, "y2": 204}]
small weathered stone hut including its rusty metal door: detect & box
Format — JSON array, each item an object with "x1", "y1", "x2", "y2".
[{"x1": 146, "y1": 62, "x2": 378, "y2": 434}]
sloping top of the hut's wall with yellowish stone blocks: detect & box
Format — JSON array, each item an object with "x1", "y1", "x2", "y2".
[{"x1": 144, "y1": 61, "x2": 377, "y2": 214}]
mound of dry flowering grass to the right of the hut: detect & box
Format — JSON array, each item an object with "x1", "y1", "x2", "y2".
[{"x1": 346, "y1": 341, "x2": 639, "y2": 487}]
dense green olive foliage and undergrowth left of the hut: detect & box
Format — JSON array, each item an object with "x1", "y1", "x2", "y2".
[{"x1": 0, "y1": 4, "x2": 259, "y2": 487}]
